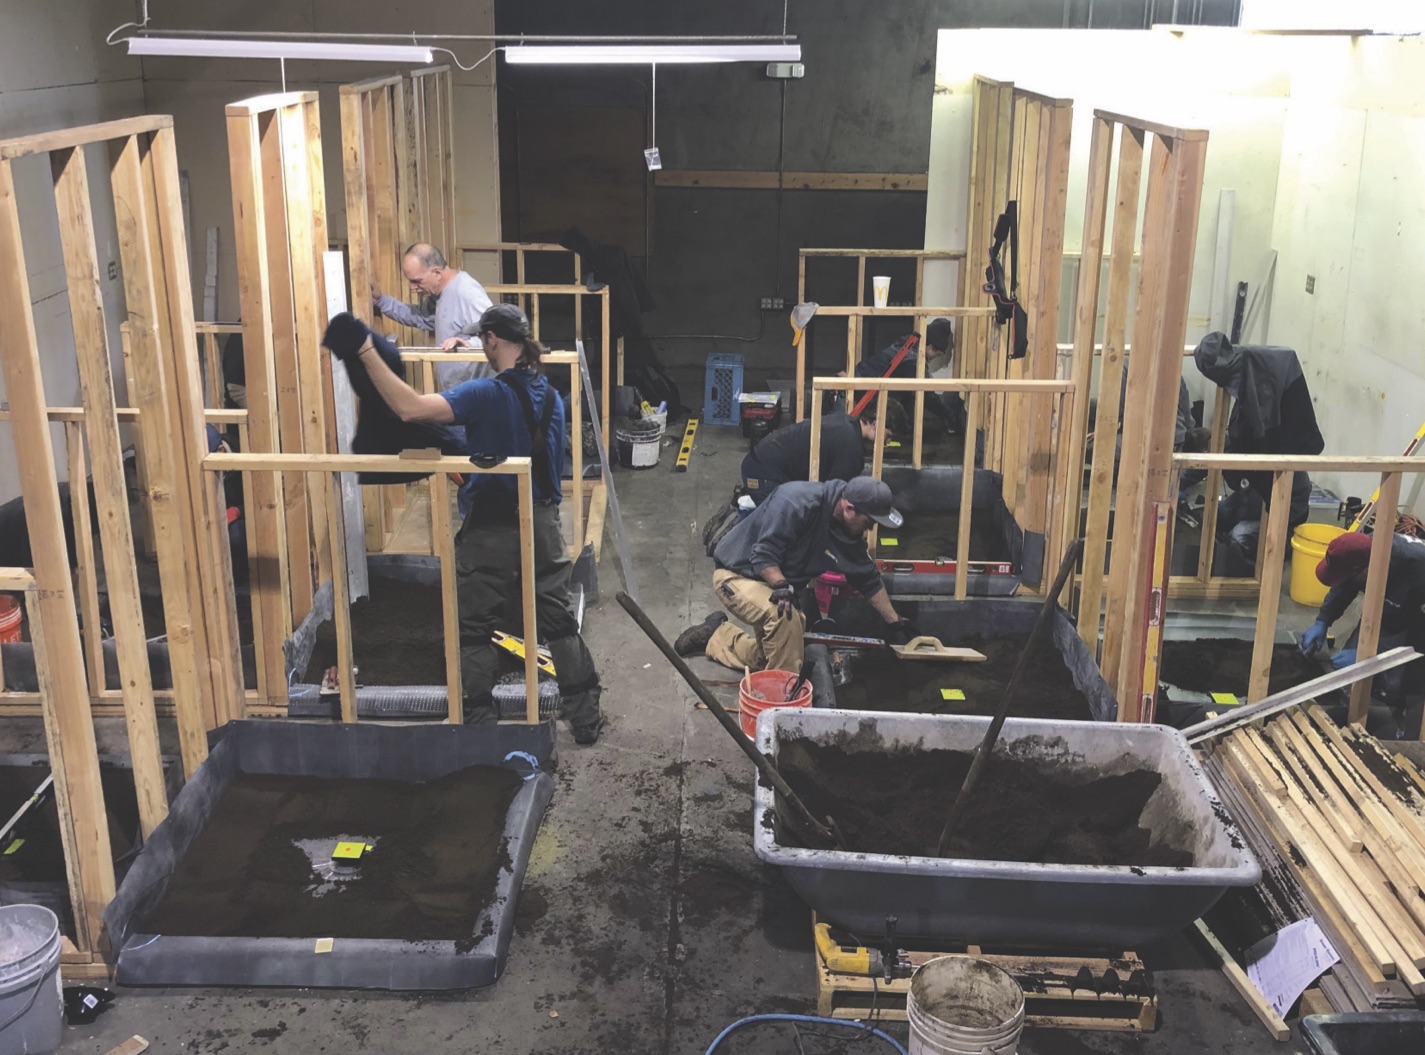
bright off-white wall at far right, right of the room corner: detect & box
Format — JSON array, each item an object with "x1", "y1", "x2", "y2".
[{"x1": 1268, "y1": 37, "x2": 1425, "y2": 510}]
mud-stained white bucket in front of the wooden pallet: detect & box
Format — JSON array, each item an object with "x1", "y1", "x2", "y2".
[{"x1": 905, "y1": 957, "x2": 1025, "y2": 1055}]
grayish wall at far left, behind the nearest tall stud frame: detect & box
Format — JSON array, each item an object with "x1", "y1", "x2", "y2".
[{"x1": 0, "y1": 0, "x2": 144, "y2": 502}]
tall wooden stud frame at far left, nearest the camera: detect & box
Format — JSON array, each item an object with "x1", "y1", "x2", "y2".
[{"x1": 0, "y1": 117, "x2": 252, "y2": 962}]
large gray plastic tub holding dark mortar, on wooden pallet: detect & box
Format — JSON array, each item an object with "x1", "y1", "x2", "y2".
[{"x1": 752, "y1": 707, "x2": 1261, "y2": 950}]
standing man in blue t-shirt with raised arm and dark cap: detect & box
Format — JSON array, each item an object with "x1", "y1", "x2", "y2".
[{"x1": 322, "y1": 304, "x2": 603, "y2": 744}]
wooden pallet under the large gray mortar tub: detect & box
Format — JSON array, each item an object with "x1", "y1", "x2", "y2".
[{"x1": 815, "y1": 945, "x2": 1157, "y2": 1032}]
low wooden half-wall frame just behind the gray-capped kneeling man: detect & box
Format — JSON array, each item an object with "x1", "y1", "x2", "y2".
[{"x1": 809, "y1": 378, "x2": 1074, "y2": 600}]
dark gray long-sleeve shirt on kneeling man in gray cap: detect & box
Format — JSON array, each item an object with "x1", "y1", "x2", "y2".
[{"x1": 714, "y1": 480, "x2": 885, "y2": 597}]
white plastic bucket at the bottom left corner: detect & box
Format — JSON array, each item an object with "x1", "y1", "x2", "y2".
[{"x1": 0, "y1": 905, "x2": 64, "y2": 1055}]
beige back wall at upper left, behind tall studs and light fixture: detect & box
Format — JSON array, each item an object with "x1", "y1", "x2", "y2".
[{"x1": 144, "y1": 0, "x2": 500, "y2": 321}]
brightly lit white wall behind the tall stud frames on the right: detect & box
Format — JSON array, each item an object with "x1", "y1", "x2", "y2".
[{"x1": 926, "y1": 30, "x2": 1290, "y2": 405}]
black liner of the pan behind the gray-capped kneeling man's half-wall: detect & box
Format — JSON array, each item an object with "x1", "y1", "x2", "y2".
[{"x1": 881, "y1": 465, "x2": 1045, "y2": 597}]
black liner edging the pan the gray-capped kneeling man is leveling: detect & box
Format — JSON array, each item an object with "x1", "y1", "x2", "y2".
[{"x1": 807, "y1": 597, "x2": 1119, "y2": 721}]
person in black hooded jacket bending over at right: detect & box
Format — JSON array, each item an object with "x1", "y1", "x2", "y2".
[{"x1": 1193, "y1": 334, "x2": 1325, "y2": 555}]
